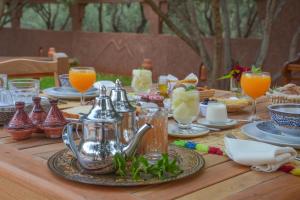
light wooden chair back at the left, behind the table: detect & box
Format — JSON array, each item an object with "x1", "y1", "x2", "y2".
[{"x1": 0, "y1": 58, "x2": 59, "y2": 87}]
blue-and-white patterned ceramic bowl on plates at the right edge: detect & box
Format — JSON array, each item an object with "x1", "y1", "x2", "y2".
[{"x1": 268, "y1": 104, "x2": 300, "y2": 137}]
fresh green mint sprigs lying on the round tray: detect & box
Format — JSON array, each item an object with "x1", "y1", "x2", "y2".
[{"x1": 113, "y1": 154, "x2": 182, "y2": 181}]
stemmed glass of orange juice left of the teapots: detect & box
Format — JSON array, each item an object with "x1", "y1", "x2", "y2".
[{"x1": 69, "y1": 67, "x2": 96, "y2": 105}]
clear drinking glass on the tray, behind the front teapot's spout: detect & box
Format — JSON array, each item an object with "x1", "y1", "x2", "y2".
[{"x1": 137, "y1": 107, "x2": 168, "y2": 161}]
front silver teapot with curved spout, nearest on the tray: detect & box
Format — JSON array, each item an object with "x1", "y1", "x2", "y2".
[{"x1": 62, "y1": 86, "x2": 151, "y2": 174}]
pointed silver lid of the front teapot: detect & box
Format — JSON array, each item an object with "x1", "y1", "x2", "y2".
[{"x1": 83, "y1": 85, "x2": 121, "y2": 123}]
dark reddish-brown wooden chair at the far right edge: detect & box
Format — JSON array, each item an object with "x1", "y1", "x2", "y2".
[{"x1": 282, "y1": 53, "x2": 300, "y2": 84}]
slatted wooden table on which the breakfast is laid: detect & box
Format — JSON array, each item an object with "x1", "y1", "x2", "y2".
[{"x1": 0, "y1": 92, "x2": 300, "y2": 200}]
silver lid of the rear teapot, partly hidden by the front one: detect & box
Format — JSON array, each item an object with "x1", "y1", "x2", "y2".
[{"x1": 110, "y1": 79, "x2": 135, "y2": 112}]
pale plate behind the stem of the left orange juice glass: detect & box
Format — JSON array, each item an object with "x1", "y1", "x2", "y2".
[{"x1": 43, "y1": 87, "x2": 99, "y2": 100}]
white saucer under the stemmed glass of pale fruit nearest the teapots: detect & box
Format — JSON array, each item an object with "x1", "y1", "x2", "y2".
[{"x1": 168, "y1": 123, "x2": 209, "y2": 138}]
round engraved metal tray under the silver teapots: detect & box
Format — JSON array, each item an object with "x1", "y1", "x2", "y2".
[{"x1": 48, "y1": 145, "x2": 205, "y2": 186}]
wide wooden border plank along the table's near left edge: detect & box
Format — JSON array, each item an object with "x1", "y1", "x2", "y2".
[{"x1": 0, "y1": 145, "x2": 138, "y2": 200}]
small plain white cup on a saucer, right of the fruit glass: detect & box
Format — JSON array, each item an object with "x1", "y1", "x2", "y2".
[{"x1": 206, "y1": 102, "x2": 228, "y2": 123}]
